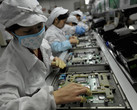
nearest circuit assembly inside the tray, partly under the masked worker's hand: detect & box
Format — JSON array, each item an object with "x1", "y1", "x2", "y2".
[{"x1": 59, "y1": 73, "x2": 115, "y2": 103}]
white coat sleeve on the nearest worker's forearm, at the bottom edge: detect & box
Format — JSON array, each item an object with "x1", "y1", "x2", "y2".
[{"x1": 0, "y1": 86, "x2": 56, "y2": 110}]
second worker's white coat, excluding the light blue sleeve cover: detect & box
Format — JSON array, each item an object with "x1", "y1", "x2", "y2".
[{"x1": 44, "y1": 25, "x2": 71, "y2": 56}]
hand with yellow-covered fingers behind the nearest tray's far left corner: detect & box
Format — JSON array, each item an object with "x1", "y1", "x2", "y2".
[{"x1": 51, "y1": 57, "x2": 66, "y2": 69}]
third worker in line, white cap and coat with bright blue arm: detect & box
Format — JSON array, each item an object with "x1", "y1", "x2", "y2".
[{"x1": 62, "y1": 15, "x2": 85, "y2": 36}]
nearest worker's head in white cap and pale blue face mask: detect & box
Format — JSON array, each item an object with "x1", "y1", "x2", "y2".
[{"x1": 0, "y1": 0, "x2": 47, "y2": 49}]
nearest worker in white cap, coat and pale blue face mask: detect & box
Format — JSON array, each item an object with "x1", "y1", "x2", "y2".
[{"x1": 0, "y1": 0, "x2": 88, "y2": 110}]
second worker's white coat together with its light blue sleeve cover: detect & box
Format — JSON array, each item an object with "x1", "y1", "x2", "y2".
[{"x1": 44, "y1": 25, "x2": 72, "y2": 57}]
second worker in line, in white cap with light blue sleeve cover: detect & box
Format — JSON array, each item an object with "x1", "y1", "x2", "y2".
[{"x1": 44, "y1": 7, "x2": 78, "y2": 56}]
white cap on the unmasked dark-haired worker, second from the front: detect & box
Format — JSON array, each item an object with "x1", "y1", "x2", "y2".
[{"x1": 46, "y1": 7, "x2": 68, "y2": 27}]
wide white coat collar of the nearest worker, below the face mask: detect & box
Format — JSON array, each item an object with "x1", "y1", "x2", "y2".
[{"x1": 13, "y1": 39, "x2": 39, "y2": 70}]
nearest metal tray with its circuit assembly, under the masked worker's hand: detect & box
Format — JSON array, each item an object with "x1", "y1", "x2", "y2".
[{"x1": 54, "y1": 72, "x2": 129, "y2": 110}]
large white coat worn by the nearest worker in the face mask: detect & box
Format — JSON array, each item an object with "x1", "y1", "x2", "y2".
[{"x1": 0, "y1": 39, "x2": 56, "y2": 110}]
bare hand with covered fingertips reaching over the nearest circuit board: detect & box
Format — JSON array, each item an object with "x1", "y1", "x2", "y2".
[{"x1": 53, "y1": 83, "x2": 91, "y2": 104}]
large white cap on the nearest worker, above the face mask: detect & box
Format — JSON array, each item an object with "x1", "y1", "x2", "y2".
[{"x1": 0, "y1": 0, "x2": 47, "y2": 27}]
